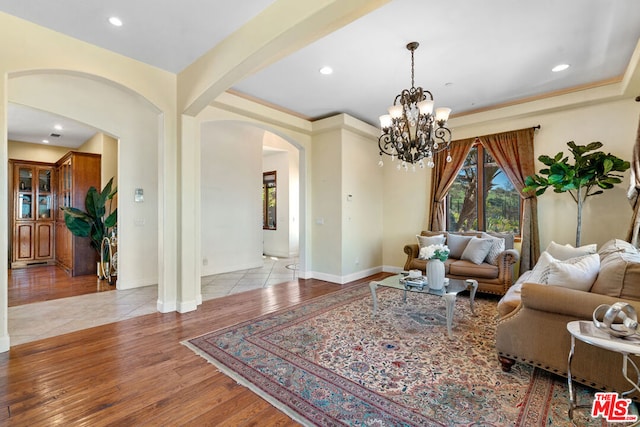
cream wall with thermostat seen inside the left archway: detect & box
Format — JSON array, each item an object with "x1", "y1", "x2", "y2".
[{"x1": 8, "y1": 73, "x2": 159, "y2": 289}]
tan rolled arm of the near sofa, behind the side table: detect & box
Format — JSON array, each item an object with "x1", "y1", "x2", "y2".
[{"x1": 514, "y1": 283, "x2": 640, "y2": 320}]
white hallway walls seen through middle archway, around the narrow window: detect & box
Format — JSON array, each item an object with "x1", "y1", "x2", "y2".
[{"x1": 200, "y1": 120, "x2": 305, "y2": 300}]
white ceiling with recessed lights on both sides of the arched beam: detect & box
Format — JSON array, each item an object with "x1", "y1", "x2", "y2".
[{"x1": 0, "y1": 0, "x2": 640, "y2": 147}]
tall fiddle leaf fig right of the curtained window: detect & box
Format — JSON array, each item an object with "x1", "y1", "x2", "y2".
[{"x1": 524, "y1": 141, "x2": 630, "y2": 246}]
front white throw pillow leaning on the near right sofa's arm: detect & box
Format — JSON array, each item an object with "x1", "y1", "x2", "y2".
[{"x1": 541, "y1": 254, "x2": 600, "y2": 292}]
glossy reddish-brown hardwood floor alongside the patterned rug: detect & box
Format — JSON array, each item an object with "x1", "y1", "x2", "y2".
[{"x1": 0, "y1": 273, "x2": 387, "y2": 426}]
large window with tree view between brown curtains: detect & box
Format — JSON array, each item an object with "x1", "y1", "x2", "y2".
[{"x1": 446, "y1": 144, "x2": 521, "y2": 235}]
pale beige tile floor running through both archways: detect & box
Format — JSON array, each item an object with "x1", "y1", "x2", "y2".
[{"x1": 9, "y1": 257, "x2": 298, "y2": 346}]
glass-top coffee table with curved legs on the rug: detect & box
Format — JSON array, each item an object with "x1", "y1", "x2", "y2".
[{"x1": 369, "y1": 274, "x2": 478, "y2": 338}]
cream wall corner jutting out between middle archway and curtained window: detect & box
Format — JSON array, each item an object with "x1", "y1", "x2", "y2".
[{"x1": 312, "y1": 114, "x2": 383, "y2": 283}]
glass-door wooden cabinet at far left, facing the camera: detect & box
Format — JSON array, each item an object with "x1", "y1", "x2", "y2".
[{"x1": 10, "y1": 161, "x2": 55, "y2": 268}]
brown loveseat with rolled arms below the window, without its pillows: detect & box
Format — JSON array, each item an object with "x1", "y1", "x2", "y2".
[{"x1": 404, "y1": 231, "x2": 520, "y2": 295}]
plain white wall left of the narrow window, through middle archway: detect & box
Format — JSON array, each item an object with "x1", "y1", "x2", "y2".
[{"x1": 200, "y1": 122, "x2": 264, "y2": 276}]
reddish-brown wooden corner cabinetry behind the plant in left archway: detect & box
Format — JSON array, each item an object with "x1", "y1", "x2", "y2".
[{"x1": 10, "y1": 151, "x2": 101, "y2": 276}]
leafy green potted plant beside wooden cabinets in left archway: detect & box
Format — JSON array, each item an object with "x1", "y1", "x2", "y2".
[{"x1": 60, "y1": 178, "x2": 118, "y2": 278}]
